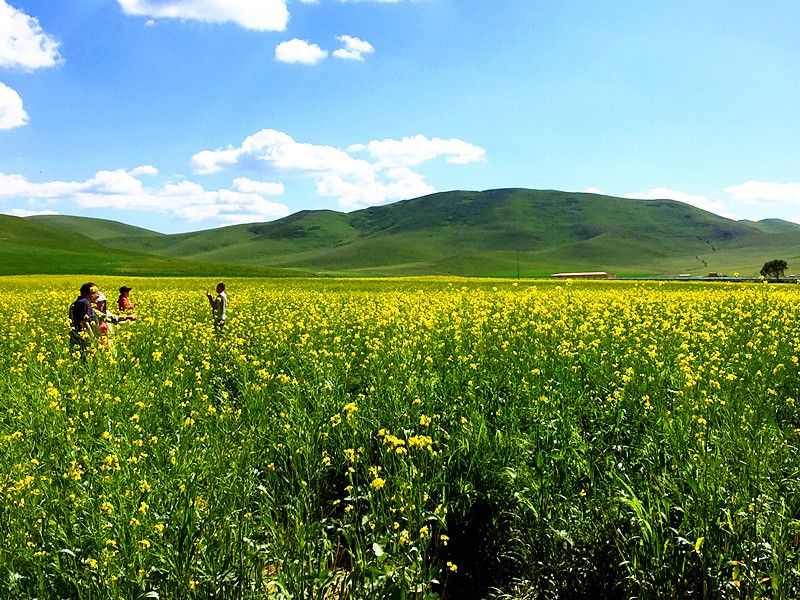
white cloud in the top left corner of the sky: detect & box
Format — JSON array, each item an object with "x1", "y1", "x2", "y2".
[{"x1": 0, "y1": 0, "x2": 62, "y2": 70}]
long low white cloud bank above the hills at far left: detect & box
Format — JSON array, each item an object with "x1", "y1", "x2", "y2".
[{"x1": 0, "y1": 166, "x2": 289, "y2": 223}]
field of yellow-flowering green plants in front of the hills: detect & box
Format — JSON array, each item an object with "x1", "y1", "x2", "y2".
[{"x1": 0, "y1": 277, "x2": 800, "y2": 599}]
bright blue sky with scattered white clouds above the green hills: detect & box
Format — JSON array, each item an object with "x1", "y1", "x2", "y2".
[{"x1": 0, "y1": 0, "x2": 800, "y2": 233}]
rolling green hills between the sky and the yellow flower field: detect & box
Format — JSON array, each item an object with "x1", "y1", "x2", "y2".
[{"x1": 6, "y1": 188, "x2": 800, "y2": 276}]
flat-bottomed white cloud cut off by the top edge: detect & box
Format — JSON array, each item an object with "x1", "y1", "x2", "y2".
[{"x1": 115, "y1": 0, "x2": 289, "y2": 31}]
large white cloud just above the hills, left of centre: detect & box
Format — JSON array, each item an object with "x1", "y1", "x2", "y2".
[{"x1": 192, "y1": 129, "x2": 485, "y2": 210}]
